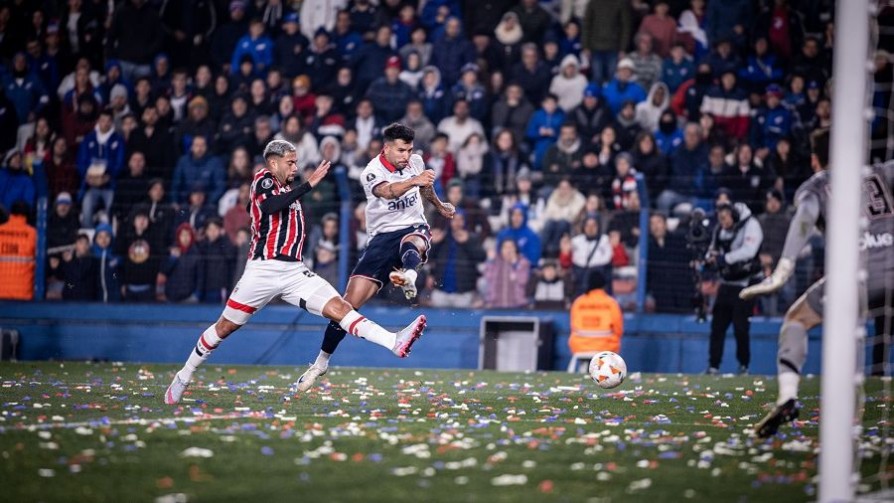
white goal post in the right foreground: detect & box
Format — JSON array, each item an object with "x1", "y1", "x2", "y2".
[{"x1": 819, "y1": 0, "x2": 870, "y2": 503}]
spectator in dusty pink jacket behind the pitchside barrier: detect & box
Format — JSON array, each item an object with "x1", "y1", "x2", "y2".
[{"x1": 484, "y1": 239, "x2": 531, "y2": 309}]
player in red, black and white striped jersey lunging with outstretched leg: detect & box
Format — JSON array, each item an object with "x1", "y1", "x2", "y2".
[{"x1": 164, "y1": 140, "x2": 425, "y2": 405}]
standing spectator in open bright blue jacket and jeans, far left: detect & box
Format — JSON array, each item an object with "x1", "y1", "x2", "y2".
[{"x1": 77, "y1": 110, "x2": 125, "y2": 227}]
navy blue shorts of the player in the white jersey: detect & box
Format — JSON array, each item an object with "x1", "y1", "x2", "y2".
[{"x1": 351, "y1": 224, "x2": 431, "y2": 288}]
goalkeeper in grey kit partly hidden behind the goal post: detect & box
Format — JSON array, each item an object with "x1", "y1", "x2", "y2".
[{"x1": 739, "y1": 130, "x2": 894, "y2": 438}]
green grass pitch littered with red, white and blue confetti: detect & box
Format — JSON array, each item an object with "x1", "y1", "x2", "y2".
[{"x1": 0, "y1": 362, "x2": 894, "y2": 503}]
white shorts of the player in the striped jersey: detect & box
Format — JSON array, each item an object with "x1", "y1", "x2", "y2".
[{"x1": 223, "y1": 260, "x2": 338, "y2": 325}]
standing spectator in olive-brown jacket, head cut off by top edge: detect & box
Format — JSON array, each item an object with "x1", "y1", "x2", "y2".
[{"x1": 581, "y1": 0, "x2": 632, "y2": 84}]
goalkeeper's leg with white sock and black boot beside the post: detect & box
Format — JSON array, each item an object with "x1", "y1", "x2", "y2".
[{"x1": 754, "y1": 280, "x2": 825, "y2": 438}]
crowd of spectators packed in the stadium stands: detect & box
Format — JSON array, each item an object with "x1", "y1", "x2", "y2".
[{"x1": 0, "y1": 0, "x2": 892, "y2": 314}]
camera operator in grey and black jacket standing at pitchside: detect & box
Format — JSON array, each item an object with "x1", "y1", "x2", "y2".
[{"x1": 705, "y1": 203, "x2": 764, "y2": 374}]
